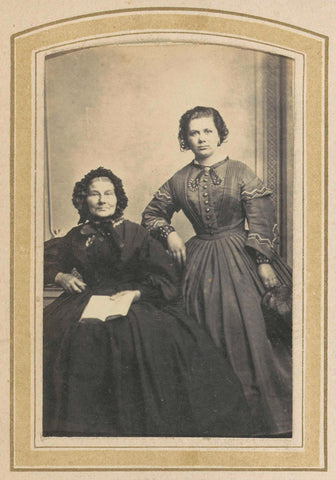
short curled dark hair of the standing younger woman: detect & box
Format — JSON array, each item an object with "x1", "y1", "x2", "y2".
[{"x1": 178, "y1": 107, "x2": 229, "y2": 150}]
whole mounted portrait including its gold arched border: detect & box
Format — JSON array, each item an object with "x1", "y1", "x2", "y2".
[{"x1": 12, "y1": 8, "x2": 327, "y2": 471}]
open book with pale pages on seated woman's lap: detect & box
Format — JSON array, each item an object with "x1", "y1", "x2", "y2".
[{"x1": 79, "y1": 291, "x2": 136, "y2": 322}]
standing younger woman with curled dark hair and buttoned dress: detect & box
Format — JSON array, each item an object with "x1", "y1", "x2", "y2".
[{"x1": 143, "y1": 107, "x2": 292, "y2": 436}]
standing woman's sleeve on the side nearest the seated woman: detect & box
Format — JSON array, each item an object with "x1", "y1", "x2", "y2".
[{"x1": 142, "y1": 179, "x2": 181, "y2": 243}]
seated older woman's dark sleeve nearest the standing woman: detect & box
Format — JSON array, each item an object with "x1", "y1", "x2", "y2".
[{"x1": 139, "y1": 229, "x2": 180, "y2": 303}]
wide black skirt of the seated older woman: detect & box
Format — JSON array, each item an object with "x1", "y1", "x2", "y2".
[{"x1": 43, "y1": 292, "x2": 251, "y2": 437}]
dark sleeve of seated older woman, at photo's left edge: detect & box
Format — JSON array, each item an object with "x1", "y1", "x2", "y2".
[{"x1": 44, "y1": 232, "x2": 72, "y2": 285}]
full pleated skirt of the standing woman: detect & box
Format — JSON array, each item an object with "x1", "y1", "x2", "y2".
[{"x1": 184, "y1": 230, "x2": 292, "y2": 436}]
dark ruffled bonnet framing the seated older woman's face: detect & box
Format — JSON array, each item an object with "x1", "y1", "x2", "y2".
[{"x1": 72, "y1": 167, "x2": 128, "y2": 223}]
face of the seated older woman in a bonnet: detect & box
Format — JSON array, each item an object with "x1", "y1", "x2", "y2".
[{"x1": 87, "y1": 177, "x2": 117, "y2": 218}]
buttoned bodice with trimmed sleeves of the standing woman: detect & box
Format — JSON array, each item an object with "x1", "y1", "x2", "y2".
[{"x1": 142, "y1": 157, "x2": 278, "y2": 258}]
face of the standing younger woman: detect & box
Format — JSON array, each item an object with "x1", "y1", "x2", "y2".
[{"x1": 188, "y1": 117, "x2": 220, "y2": 159}]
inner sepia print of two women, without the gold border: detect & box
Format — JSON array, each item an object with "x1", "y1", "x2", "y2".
[{"x1": 43, "y1": 42, "x2": 294, "y2": 437}]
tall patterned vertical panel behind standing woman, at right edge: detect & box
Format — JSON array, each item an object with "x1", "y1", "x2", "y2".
[{"x1": 255, "y1": 53, "x2": 294, "y2": 265}]
